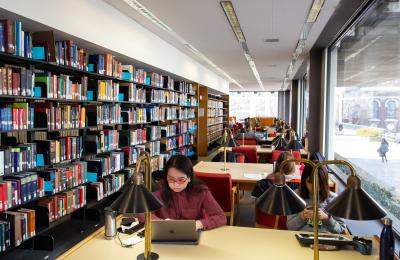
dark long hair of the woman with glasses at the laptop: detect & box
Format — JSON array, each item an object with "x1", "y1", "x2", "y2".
[{"x1": 161, "y1": 154, "x2": 207, "y2": 207}]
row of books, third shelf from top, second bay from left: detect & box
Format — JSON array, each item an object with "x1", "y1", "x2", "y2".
[{"x1": 34, "y1": 102, "x2": 86, "y2": 130}]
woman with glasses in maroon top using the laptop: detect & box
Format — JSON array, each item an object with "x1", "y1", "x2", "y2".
[{"x1": 145, "y1": 155, "x2": 226, "y2": 230}]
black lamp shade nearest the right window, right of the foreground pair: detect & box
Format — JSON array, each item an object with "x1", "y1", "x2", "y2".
[{"x1": 326, "y1": 188, "x2": 386, "y2": 220}]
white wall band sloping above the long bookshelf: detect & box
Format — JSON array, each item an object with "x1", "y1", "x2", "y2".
[{"x1": 0, "y1": 0, "x2": 229, "y2": 93}]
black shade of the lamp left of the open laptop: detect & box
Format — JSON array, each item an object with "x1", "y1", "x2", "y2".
[{"x1": 111, "y1": 181, "x2": 163, "y2": 214}]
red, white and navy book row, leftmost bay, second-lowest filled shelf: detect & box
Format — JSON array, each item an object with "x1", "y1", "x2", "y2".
[{"x1": 0, "y1": 172, "x2": 44, "y2": 212}]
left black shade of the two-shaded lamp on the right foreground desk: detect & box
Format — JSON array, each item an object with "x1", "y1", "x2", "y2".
[{"x1": 256, "y1": 184, "x2": 306, "y2": 216}]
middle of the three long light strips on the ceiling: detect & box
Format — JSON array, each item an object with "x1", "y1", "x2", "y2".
[{"x1": 220, "y1": 1, "x2": 264, "y2": 90}]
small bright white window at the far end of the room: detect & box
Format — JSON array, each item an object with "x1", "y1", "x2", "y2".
[{"x1": 229, "y1": 91, "x2": 278, "y2": 121}]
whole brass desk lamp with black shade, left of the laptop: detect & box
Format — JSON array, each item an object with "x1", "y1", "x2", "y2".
[{"x1": 111, "y1": 151, "x2": 163, "y2": 260}]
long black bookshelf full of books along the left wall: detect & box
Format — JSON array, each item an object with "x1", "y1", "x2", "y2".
[{"x1": 0, "y1": 14, "x2": 199, "y2": 259}]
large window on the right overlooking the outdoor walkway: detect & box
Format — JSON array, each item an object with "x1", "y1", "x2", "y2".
[{"x1": 328, "y1": 1, "x2": 400, "y2": 231}]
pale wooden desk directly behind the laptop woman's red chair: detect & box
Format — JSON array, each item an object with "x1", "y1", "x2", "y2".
[{"x1": 193, "y1": 161, "x2": 300, "y2": 190}]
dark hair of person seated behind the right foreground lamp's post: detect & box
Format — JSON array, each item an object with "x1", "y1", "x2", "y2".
[{"x1": 300, "y1": 164, "x2": 329, "y2": 202}]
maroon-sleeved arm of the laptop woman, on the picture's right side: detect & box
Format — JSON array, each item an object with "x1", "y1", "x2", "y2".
[{"x1": 196, "y1": 190, "x2": 226, "y2": 230}]
